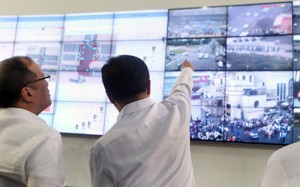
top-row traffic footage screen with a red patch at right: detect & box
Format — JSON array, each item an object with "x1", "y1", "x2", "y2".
[{"x1": 228, "y1": 2, "x2": 293, "y2": 36}]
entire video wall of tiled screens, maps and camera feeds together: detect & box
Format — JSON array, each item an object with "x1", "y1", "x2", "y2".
[{"x1": 0, "y1": 1, "x2": 300, "y2": 144}]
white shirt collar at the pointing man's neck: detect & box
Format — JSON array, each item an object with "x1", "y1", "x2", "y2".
[{"x1": 117, "y1": 97, "x2": 154, "y2": 120}]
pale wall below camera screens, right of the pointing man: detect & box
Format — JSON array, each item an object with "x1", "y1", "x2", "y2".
[{"x1": 191, "y1": 142, "x2": 280, "y2": 187}]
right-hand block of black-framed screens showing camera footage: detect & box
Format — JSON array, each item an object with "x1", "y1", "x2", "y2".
[{"x1": 164, "y1": 2, "x2": 300, "y2": 144}]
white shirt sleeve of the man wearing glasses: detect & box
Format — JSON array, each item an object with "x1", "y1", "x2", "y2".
[{"x1": 25, "y1": 131, "x2": 65, "y2": 187}]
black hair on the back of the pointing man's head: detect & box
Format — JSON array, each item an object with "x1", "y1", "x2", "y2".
[{"x1": 101, "y1": 55, "x2": 150, "y2": 102}]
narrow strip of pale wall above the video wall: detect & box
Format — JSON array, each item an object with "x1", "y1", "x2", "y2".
[{"x1": 0, "y1": 0, "x2": 287, "y2": 15}]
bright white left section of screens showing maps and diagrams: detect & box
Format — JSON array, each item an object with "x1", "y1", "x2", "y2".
[{"x1": 0, "y1": 10, "x2": 168, "y2": 135}]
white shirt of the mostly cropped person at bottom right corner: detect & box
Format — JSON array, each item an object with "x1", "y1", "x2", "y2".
[{"x1": 257, "y1": 142, "x2": 300, "y2": 187}]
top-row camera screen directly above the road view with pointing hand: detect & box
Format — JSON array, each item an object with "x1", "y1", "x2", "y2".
[{"x1": 168, "y1": 7, "x2": 227, "y2": 38}]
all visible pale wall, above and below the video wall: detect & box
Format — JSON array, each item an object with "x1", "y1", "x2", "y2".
[{"x1": 0, "y1": 0, "x2": 290, "y2": 187}]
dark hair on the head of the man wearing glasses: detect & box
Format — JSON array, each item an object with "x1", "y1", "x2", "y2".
[{"x1": 0, "y1": 56, "x2": 35, "y2": 108}]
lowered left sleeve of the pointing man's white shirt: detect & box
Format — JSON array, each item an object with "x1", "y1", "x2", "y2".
[{"x1": 89, "y1": 144, "x2": 115, "y2": 187}]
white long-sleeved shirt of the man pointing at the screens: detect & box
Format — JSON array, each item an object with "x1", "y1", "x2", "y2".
[{"x1": 90, "y1": 68, "x2": 195, "y2": 187}]
